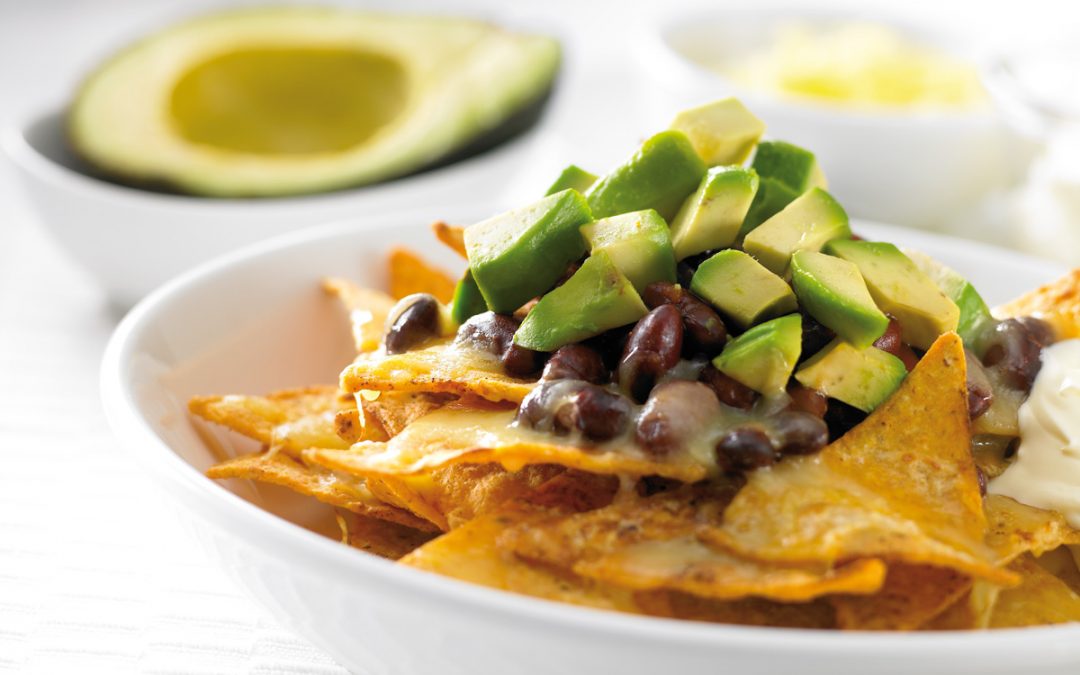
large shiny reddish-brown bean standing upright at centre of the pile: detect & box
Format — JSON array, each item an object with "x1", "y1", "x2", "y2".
[{"x1": 618, "y1": 305, "x2": 683, "y2": 403}]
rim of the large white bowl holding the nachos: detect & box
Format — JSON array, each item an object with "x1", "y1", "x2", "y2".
[{"x1": 99, "y1": 212, "x2": 1080, "y2": 664}]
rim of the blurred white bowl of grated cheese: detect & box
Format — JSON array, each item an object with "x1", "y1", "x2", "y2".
[{"x1": 636, "y1": 2, "x2": 998, "y2": 127}]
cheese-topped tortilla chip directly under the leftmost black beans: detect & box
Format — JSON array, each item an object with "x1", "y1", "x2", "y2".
[{"x1": 341, "y1": 340, "x2": 536, "y2": 405}]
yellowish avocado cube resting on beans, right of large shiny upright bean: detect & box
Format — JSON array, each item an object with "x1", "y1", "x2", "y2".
[{"x1": 690, "y1": 248, "x2": 798, "y2": 328}]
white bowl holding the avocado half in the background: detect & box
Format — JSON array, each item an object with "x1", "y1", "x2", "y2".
[{"x1": 0, "y1": 108, "x2": 542, "y2": 309}]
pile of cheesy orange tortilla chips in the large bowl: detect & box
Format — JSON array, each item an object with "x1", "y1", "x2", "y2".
[{"x1": 190, "y1": 235, "x2": 1080, "y2": 630}]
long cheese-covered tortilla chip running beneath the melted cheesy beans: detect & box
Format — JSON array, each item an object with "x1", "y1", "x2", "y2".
[{"x1": 306, "y1": 403, "x2": 713, "y2": 483}]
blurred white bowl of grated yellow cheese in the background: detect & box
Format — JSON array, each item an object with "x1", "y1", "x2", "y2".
[{"x1": 635, "y1": 6, "x2": 1024, "y2": 229}]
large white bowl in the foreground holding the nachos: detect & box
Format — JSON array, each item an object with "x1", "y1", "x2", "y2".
[{"x1": 102, "y1": 212, "x2": 1080, "y2": 675}]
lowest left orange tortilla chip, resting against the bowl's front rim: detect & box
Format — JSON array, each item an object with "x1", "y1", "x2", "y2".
[{"x1": 400, "y1": 510, "x2": 640, "y2": 613}]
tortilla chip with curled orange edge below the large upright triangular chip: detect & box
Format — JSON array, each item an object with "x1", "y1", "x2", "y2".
[{"x1": 499, "y1": 484, "x2": 885, "y2": 602}]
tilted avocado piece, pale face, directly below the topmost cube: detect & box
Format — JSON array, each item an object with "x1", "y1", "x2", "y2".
[{"x1": 671, "y1": 166, "x2": 758, "y2": 260}]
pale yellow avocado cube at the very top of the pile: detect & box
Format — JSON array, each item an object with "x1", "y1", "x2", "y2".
[{"x1": 671, "y1": 98, "x2": 765, "y2": 166}]
